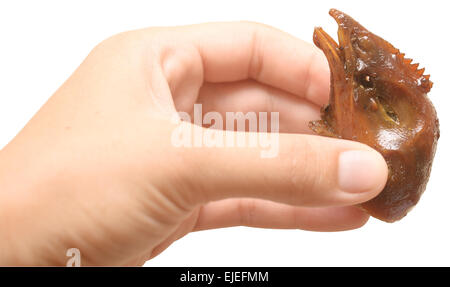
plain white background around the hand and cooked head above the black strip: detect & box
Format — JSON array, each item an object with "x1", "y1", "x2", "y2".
[{"x1": 0, "y1": 0, "x2": 450, "y2": 266}]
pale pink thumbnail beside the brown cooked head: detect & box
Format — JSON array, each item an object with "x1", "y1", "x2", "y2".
[{"x1": 338, "y1": 150, "x2": 387, "y2": 193}]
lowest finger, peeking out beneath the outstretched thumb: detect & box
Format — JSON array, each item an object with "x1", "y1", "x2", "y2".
[{"x1": 194, "y1": 198, "x2": 369, "y2": 231}]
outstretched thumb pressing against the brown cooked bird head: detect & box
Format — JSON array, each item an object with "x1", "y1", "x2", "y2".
[{"x1": 179, "y1": 125, "x2": 388, "y2": 207}]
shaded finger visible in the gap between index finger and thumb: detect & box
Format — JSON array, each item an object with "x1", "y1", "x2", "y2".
[{"x1": 197, "y1": 80, "x2": 320, "y2": 134}]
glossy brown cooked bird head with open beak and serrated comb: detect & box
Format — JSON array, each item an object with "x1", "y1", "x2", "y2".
[{"x1": 310, "y1": 9, "x2": 439, "y2": 222}]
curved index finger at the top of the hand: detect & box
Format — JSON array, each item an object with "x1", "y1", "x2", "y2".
[{"x1": 163, "y1": 22, "x2": 329, "y2": 105}]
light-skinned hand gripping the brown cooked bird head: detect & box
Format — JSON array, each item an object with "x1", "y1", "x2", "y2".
[{"x1": 0, "y1": 22, "x2": 387, "y2": 265}]
